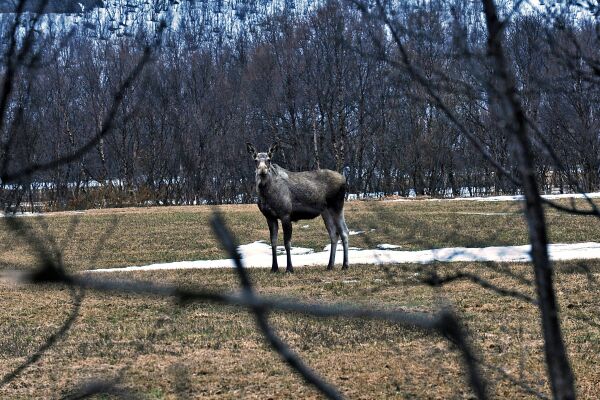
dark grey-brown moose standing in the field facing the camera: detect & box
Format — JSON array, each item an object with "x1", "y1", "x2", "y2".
[{"x1": 246, "y1": 143, "x2": 348, "y2": 272}]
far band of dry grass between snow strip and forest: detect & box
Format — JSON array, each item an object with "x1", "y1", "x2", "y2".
[{"x1": 0, "y1": 201, "x2": 600, "y2": 271}]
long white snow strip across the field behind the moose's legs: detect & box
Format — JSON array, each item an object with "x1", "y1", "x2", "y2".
[{"x1": 88, "y1": 241, "x2": 600, "y2": 272}]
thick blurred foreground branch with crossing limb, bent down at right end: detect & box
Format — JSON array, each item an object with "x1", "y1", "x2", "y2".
[{"x1": 4, "y1": 211, "x2": 487, "y2": 399}]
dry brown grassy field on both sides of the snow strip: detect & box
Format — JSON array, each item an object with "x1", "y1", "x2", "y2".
[{"x1": 0, "y1": 201, "x2": 600, "y2": 399}]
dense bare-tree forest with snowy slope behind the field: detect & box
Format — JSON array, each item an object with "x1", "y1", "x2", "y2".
[{"x1": 0, "y1": 0, "x2": 600, "y2": 211}]
